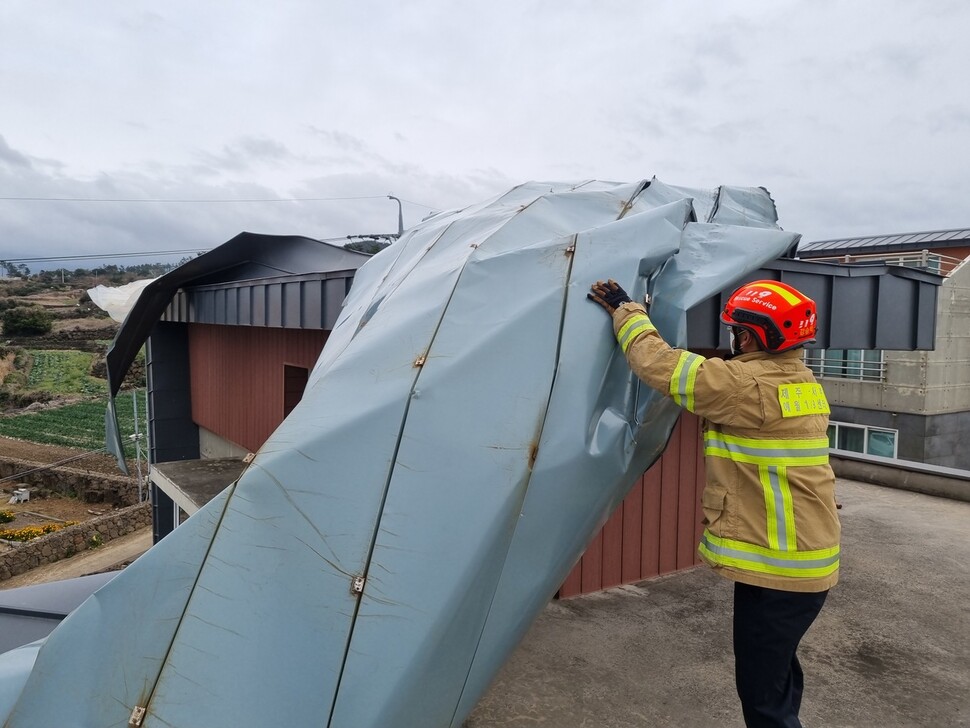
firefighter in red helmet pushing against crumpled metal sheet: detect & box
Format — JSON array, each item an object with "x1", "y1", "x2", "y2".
[{"x1": 589, "y1": 280, "x2": 840, "y2": 728}]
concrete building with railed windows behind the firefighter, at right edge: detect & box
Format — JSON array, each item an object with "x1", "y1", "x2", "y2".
[{"x1": 798, "y1": 229, "x2": 970, "y2": 470}]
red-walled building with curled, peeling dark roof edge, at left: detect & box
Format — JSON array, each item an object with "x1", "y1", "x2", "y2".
[{"x1": 99, "y1": 233, "x2": 370, "y2": 541}]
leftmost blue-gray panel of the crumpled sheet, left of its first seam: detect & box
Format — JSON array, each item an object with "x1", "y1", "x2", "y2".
[{"x1": 0, "y1": 488, "x2": 232, "y2": 728}]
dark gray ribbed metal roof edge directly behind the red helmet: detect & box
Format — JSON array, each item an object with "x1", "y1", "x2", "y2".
[{"x1": 687, "y1": 258, "x2": 944, "y2": 351}]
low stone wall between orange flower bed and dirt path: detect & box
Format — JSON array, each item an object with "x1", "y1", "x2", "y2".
[{"x1": 0, "y1": 503, "x2": 152, "y2": 581}]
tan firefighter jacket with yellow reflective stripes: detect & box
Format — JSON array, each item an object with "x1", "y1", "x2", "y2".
[{"x1": 613, "y1": 303, "x2": 840, "y2": 592}]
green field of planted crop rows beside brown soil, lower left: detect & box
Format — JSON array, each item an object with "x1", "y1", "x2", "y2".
[{"x1": 0, "y1": 392, "x2": 145, "y2": 457}]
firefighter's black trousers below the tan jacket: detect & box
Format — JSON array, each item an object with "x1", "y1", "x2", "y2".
[{"x1": 734, "y1": 582, "x2": 828, "y2": 728}]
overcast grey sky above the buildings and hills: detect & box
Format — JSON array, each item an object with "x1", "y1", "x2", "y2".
[{"x1": 0, "y1": 0, "x2": 970, "y2": 270}]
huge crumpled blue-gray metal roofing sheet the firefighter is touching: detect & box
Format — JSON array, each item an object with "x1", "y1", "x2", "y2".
[{"x1": 0, "y1": 180, "x2": 797, "y2": 728}]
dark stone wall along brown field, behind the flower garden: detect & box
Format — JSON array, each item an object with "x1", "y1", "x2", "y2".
[{"x1": 0, "y1": 457, "x2": 138, "y2": 506}]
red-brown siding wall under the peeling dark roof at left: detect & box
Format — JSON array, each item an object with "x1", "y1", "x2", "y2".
[{"x1": 189, "y1": 324, "x2": 328, "y2": 452}]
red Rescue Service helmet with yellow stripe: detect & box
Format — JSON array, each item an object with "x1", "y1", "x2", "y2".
[{"x1": 721, "y1": 281, "x2": 818, "y2": 354}]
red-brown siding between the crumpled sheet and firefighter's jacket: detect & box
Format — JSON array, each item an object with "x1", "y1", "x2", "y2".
[{"x1": 559, "y1": 412, "x2": 704, "y2": 598}]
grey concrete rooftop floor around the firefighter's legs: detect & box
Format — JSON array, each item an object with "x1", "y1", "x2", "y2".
[{"x1": 466, "y1": 479, "x2": 970, "y2": 728}]
